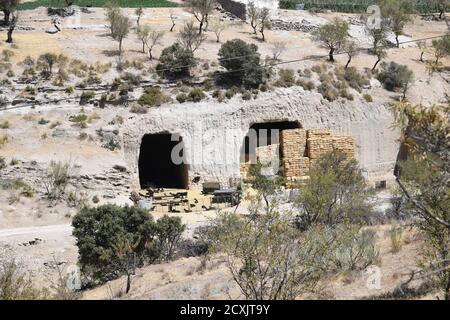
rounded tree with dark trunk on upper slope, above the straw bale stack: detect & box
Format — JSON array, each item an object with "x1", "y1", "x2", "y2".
[{"x1": 313, "y1": 18, "x2": 349, "y2": 62}]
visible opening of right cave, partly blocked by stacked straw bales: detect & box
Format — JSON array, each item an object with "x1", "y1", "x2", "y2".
[{"x1": 241, "y1": 121, "x2": 301, "y2": 163}]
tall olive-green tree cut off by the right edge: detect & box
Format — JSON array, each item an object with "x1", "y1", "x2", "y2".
[{"x1": 392, "y1": 103, "x2": 450, "y2": 300}]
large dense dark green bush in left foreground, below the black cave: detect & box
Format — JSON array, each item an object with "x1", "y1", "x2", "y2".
[{"x1": 72, "y1": 205, "x2": 155, "y2": 282}]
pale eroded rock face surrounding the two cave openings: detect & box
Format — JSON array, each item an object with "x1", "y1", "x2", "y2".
[{"x1": 123, "y1": 87, "x2": 399, "y2": 188}]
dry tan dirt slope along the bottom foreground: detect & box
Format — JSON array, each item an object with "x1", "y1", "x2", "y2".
[{"x1": 83, "y1": 225, "x2": 439, "y2": 300}]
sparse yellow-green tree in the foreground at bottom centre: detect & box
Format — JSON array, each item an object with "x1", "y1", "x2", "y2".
[{"x1": 211, "y1": 212, "x2": 324, "y2": 300}]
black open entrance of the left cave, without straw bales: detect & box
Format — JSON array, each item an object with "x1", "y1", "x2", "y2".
[{"x1": 139, "y1": 133, "x2": 189, "y2": 189}]
